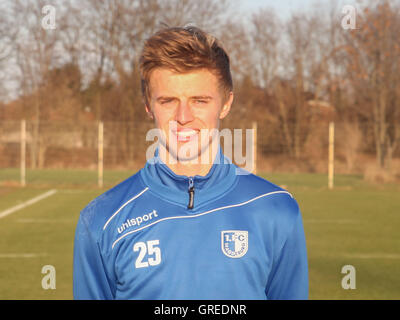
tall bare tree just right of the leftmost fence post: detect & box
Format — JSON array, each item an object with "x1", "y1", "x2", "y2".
[{"x1": 12, "y1": 0, "x2": 63, "y2": 168}]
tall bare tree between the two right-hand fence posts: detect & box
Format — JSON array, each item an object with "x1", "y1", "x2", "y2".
[{"x1": 271, "y1": 14, "x2": 319, "y2": 159}]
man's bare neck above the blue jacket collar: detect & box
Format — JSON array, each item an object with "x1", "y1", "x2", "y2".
[{"x1": 159, "y1": 144, "x2": 218, "y2": 177}]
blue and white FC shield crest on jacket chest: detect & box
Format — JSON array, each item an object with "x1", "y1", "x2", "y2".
[{"x1": 221, "y1": 230, "x2": 249, "y2": 258}]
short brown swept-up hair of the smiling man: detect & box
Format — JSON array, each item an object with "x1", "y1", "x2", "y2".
[{"x1": 139, "y1": 26, "x2": 233, "y2": 105}]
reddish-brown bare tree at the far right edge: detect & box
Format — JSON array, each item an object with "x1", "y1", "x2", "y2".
[{"x1": 344, "y1": 1, "x2": 400, "y2": 169}]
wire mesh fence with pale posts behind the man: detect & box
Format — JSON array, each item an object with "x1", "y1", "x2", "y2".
[{"x1": 0, "y1": 121, "x2": 400, "y2": 184}]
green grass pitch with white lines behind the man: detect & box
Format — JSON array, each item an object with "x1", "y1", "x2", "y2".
[{"x1": 0, "y1": 169, "x2": 400, "y2": 299}]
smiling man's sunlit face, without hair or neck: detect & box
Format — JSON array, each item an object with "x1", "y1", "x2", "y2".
[{"x1": 146, "y1": 68, "x2": 233, "y2": 160}]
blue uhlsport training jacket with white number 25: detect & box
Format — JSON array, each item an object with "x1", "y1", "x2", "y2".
[{"x1": 73, "y1": 146, "x2": 308, "y2": 300}]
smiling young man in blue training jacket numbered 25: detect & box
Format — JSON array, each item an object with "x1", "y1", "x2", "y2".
[{"x1": 73, "y1": 27, "x2": 308, "y2": 300}]
